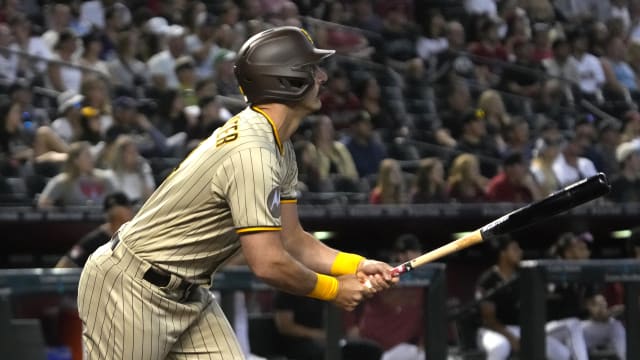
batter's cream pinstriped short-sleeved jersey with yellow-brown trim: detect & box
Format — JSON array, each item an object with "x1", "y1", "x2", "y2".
[{"x1": 119, "y1": 108, "x2": 298, "y2": 284}]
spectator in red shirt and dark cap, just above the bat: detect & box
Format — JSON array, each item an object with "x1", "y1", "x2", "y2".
[{"x1": 486, "y1": 152, "x2": 542, "y2": 203}]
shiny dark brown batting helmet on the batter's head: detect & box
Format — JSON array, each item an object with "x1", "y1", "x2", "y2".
[{"x1": 234, "y1": 26, "x2": 335, "y2": 105}]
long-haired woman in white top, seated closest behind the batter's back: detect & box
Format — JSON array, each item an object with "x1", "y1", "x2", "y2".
[{"x1": 110, "y1": 135, "x2": 156, "y2": 203}]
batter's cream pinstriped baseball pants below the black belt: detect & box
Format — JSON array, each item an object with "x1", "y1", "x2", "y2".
[{"x1": 78, "y1": 241, "x2": 244, "y2": 360}]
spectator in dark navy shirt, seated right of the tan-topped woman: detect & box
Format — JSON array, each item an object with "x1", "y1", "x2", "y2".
[{"x1": 345, "y1": 111, "x2": 387, "y2": 177}]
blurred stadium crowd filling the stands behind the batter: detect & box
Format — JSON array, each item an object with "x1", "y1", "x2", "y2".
[{"x1": 0, "y1": 0, "x2": 640, "y2": 208}]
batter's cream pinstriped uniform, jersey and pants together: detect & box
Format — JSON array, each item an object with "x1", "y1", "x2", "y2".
[{"x1": 78, "y1": 108, "x2": 298, "y2": 360}]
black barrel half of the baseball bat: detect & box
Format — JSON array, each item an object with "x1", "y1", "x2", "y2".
[{"x1": 481, "y1": 173, "x2": 611, "y2": 239}]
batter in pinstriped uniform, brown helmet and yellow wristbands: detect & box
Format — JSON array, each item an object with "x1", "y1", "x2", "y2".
[{"x1": 78, "y1": 27, "x2": 397, "y2": 360}]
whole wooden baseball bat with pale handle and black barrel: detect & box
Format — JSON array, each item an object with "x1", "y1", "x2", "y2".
[{"x1": 391, "y1": 173, "x2": 611, "y2": 276}]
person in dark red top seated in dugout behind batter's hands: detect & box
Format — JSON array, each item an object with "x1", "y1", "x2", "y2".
[{"x1": 345, "y1": 233, "x2": 425, "y2": 360}]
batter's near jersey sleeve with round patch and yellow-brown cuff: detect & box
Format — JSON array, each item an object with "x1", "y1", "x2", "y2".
[{"x1": 219, "y1": 148, "x2": 282, "y2": 234}]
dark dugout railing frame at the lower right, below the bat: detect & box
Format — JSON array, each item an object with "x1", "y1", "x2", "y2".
[{"x1": 520, "y1": 259, "x2": 640, "y2": 360}]
